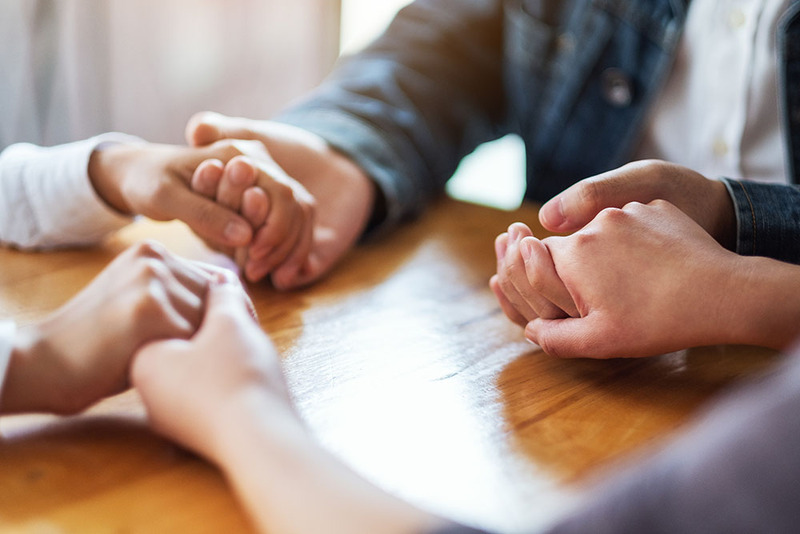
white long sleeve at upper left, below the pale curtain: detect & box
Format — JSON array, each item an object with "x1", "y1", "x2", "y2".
[{"x1": 0, "y1": 134, "x2": 141, "y2": 249}]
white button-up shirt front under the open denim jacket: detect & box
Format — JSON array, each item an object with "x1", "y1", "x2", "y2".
[{"x1": 637, "y1": 0, "x2": 788, "y2": 183}]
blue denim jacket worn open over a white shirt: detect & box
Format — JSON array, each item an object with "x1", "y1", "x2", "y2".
[{"x1": 279, "y1": 0, "x2": 800, "y2": 263}]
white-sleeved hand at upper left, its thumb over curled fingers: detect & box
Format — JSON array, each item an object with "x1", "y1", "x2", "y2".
[{"x1": 89, "y1": 141, "x2": 276, "y2": 253}]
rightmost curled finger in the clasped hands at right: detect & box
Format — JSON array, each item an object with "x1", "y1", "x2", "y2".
[{"x1": 518, "y1": 237, "x2": 580, "y2": 319}]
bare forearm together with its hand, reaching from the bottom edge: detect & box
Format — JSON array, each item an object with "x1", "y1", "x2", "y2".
[{"x1": 131, "y1": 279, "x2": 444, "y2": 533}]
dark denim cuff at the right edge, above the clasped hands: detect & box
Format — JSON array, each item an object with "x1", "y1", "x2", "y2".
[{"x1": 723, "y1": 178, "x2": 800, "y2": 264}]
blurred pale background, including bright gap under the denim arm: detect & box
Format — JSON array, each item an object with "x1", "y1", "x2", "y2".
[{"x1": 0, "y1": 0, "x2": 524, "y2": 209}]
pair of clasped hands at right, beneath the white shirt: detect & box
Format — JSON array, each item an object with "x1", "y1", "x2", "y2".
[{"x1": 490, "y1": 161, "x2": 741, "y2": 358}]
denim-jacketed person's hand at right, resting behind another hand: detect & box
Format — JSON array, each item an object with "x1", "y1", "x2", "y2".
[{"x1": 539, "y1": 160, "x2": 736, "y2": 249}]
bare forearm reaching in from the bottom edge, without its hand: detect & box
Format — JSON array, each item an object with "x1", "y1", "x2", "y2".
[{"x1": 215, "y1": 395, "x2": 442, "y2": 534}]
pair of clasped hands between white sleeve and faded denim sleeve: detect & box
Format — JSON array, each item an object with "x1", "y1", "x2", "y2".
[{"x1": 89, "y1": 113, "x2": 374, "y2": 289}]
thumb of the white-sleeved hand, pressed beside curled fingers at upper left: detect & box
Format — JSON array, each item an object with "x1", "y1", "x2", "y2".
[{"x1": 169, "y1": 189, "x2": 253, "y2": 247}]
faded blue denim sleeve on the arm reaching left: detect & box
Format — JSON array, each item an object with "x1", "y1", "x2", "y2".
[{"x1": 277, "y1": 0, "x2": 504, "y2": 234}]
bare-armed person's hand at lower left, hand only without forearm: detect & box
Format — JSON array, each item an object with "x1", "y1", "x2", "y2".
[{"x1": 131, "y1": 277, "x2": 297, "y2": 461}]
